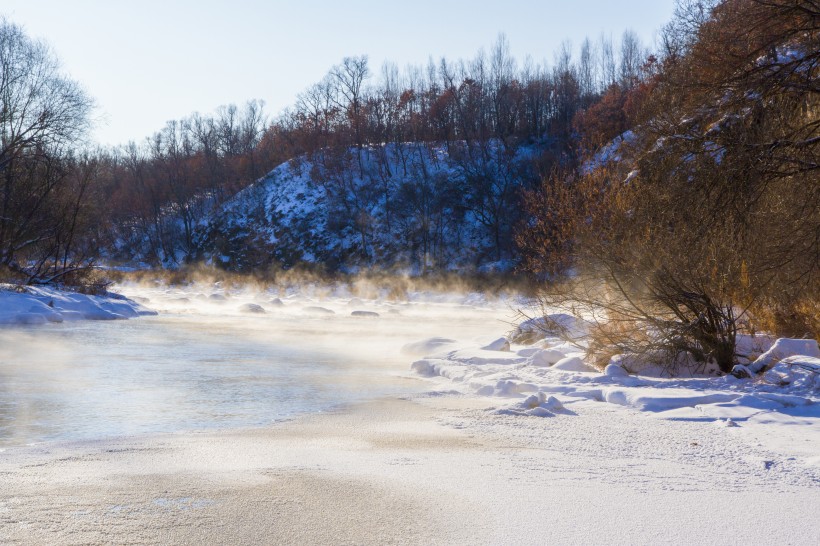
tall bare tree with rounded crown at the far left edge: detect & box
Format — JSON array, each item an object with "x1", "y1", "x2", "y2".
[{"x1": 0, "y1": 18, "x2": 96, "y2": 283}]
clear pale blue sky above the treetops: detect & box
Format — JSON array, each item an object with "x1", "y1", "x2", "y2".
[{"x1": 0, "y1": 0, "x2": 674, "y2": 144}]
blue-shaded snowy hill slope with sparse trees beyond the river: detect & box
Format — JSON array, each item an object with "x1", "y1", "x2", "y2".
[{"x1": 198, "y1": 143, "x2": 534, "y2": 272}]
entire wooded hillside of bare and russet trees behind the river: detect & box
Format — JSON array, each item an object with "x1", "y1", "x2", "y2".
[{"x1": 0, "y1": 0, "x2": 820, "y2": 369}]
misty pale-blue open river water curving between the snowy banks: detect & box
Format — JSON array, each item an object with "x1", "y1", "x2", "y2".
[{"x1": 0, "y1": 283, "x2": 514, "y2": 447}]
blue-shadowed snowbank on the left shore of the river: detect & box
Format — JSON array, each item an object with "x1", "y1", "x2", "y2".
[{"x1": 0, "y1": 284, "x2": 156, "y2": 325}]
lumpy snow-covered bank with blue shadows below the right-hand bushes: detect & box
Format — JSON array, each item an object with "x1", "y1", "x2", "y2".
[{"x1": 411, "y1": 324, "x2": 820, "y2": 467}]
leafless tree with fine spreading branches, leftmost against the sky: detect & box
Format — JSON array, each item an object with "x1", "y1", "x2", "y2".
[{"x1": 0, "y1": 19, "x2": 92, "y2": 282}]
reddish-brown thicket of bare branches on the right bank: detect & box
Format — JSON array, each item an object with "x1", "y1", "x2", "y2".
[{"x1": 521, "y1": 0, "x2": 820, "y2": 372}]
